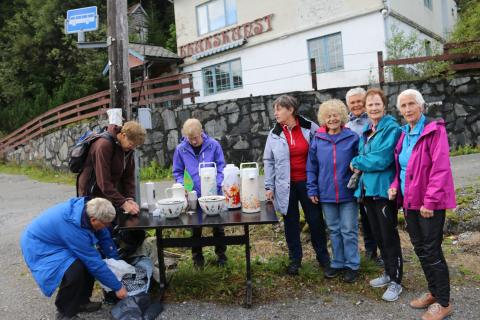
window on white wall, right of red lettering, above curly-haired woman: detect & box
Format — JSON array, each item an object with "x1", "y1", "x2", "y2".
[{"x1": 308, "y1": 32, "x2": 343, "y2": 73}]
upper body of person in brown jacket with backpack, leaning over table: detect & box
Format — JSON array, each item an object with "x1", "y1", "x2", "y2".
[{"x1": 78, "y1": 121, "x2": 146, "y2": 214}]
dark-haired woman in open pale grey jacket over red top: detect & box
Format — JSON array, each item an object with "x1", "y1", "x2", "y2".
[{"x1": 263, "y1": 95, "x2": 330, "y2": 275}]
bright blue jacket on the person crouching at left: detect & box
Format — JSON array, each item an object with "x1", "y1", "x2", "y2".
[{"x1": 20, "y1": 198, "x2": 122, "y2": 297}]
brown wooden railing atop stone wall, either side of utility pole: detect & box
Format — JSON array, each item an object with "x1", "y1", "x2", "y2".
[{"x1": 0, "y1": 74, "x2": 199, "y2": 154}]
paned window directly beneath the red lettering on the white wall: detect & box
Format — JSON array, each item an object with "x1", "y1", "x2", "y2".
[{"x1": 202, "y1": 59, "x2": 243, "y2": 95}]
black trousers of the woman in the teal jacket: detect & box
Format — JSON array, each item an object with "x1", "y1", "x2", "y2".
[{"x1": 364, "y1": 197, "x2": 403, "y2": 284}]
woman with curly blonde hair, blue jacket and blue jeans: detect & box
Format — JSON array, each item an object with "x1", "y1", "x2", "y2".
[{"x1": 307, "y1": 100, "x2": 360, "y2": 282}]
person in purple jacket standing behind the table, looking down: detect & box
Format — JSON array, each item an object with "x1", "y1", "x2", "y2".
[{"x1": 173, "y1": 118, "x2": 227, "y2": 268}]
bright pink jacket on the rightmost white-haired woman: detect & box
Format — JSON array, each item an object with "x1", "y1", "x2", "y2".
[{"x1": 390, "y1": 119, "x2": 456, "y2": 210}]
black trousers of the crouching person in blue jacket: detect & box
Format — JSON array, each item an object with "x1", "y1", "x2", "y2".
[{"x1": 55, "y1": 259, "x2": 95, "y2": 317}]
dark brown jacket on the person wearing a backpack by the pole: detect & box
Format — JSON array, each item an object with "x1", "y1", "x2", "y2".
[{"x1": 78, "y1": 125, "x2": 135, "y2": 208}]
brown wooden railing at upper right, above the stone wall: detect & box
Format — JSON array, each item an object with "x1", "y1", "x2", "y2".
[{"x1": 377, "y1": 40, "x2": 480, "y2": 85}]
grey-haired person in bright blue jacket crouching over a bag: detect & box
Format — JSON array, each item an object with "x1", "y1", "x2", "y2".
[{"x1": 20, "y1": 198, "x2": 127, "y2": 319}]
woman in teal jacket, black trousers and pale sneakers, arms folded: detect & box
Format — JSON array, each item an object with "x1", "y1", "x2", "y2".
[{"x1": 350, "y1": 88, "x2": 403, "y2": 301}]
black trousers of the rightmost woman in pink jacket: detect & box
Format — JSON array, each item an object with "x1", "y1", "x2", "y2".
[{"x1": 404, "y1": 209, "x2": 450, "y2": 307}]
